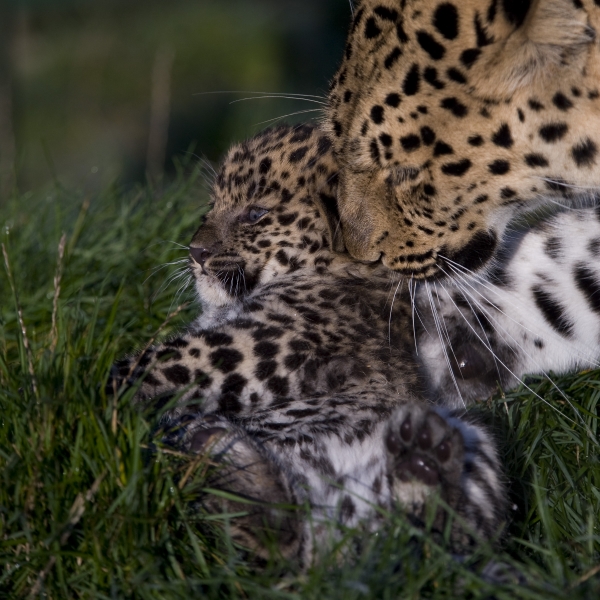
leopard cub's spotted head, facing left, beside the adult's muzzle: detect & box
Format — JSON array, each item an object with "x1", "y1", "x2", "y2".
[{"x1": 190, "y1": 125, "x2": 341, "y2": 306}]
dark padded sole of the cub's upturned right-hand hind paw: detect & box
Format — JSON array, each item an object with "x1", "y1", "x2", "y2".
[{"x1": 385, "y1": 407, "x2": 464, "y2": 486}]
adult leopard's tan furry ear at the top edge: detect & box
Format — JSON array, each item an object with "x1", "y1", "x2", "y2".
[{"x1": 470, "y1": 0, "x2": 596, "y2": 98}]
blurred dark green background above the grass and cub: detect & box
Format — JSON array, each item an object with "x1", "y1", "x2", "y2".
[{"x1": 0, "y1": 0, "x2": 350, "y2": 198}]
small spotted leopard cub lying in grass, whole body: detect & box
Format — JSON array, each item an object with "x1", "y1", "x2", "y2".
[{"x1": 115, "y1": 125, "x2": 505, "y2": 564}]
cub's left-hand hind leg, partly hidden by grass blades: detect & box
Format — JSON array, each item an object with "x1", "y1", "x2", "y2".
[{"x1": 165, "y1": 415, "x2": 306, "y2": 559}]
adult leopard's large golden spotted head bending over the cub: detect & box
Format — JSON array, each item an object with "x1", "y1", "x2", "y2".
[{"x1": 327, "y1": 0, "x2": 600, "y2": 278}]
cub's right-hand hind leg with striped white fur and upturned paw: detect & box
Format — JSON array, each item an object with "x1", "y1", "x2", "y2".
[{"x1": 384, "y1": 404, "x2": 506, "y2": 552}]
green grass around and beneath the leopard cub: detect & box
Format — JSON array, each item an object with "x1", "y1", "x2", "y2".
[{"x1": 0, "y1": 168, "x2": 600, "y2": 600}]
